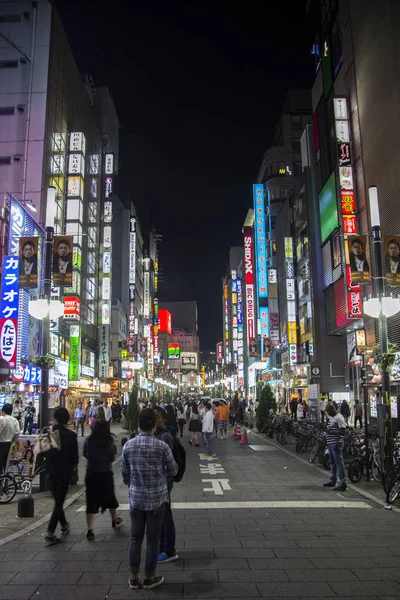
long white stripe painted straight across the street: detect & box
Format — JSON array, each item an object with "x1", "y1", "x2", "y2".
[{"x1": 76, "y1": 500, "x2": 371, "y2": 512}]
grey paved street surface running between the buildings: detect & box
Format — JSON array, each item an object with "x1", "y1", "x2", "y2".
[{"x1": 0, "y1": 426, "x2": 400, "y2": 600}]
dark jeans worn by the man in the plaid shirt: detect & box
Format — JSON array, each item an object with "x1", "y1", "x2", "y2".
[{"x1": 129, "y1": 504, "x2": 165, "y2": 577}]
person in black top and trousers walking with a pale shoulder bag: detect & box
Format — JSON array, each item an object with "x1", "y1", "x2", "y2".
[{"x1": 44, "y1": 407, "x2": 79, "y2": 546}]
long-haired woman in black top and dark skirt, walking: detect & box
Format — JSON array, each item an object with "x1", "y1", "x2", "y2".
[{"x1": 83, "y1": 420, "x2": 122, "y2": 542}]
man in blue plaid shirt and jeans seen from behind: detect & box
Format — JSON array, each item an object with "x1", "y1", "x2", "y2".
[{"x1": 121, "y1": 408, "x2": 178, "y2": 590}]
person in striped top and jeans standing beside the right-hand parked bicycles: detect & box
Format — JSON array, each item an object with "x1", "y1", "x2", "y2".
[{"x1": 324, "y1": 402, "x2": 347, "y2": 492}]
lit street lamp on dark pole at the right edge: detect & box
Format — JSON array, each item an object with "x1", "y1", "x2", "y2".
[{"x1": 364, "y1": 186, "x2": 400, "y2": 470}]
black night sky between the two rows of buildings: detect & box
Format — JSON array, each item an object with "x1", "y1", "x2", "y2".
[{"x1": 56, "y1": 0, "x2": 314, "y2": 350}]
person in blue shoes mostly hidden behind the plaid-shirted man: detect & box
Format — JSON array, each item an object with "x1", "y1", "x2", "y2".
[{"x1": 154, "y1": 407, "x2": 178, "y2": 563}]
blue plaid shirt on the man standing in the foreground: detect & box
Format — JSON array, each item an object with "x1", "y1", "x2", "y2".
[{"x1": 121, "y1": 432, "x2": 178, "y2": 511}]
